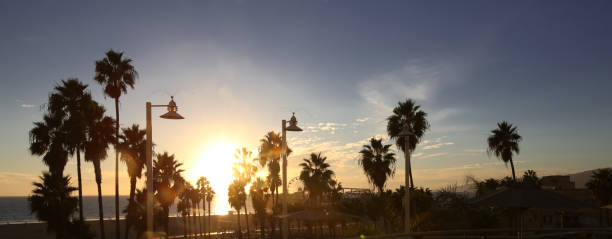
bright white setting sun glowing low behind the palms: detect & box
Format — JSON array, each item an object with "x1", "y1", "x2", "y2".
[{"x1": 187, "y1": 142, "x2": 238, "y2": 214}]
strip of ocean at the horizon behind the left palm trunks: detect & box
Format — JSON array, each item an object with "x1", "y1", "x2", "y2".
[{"x1": 0, "y1": 196, "x2": 253, "y2": 224}]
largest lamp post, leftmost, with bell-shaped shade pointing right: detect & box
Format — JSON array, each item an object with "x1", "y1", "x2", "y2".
[{"x1": 146, "y1": 96, "x2": 184, "y2": 238}]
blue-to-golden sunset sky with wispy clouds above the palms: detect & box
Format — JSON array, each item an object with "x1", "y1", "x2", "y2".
[{"x1": 0, "y1": 0, "x2": 612, "y2": 205}]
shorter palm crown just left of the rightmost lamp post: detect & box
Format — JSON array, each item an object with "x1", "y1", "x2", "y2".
[{"x1": 358, "y1": 138, "x2": 396, "y2": 195}]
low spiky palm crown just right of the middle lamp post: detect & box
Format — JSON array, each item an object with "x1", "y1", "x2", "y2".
[{"x1": 300, "y1": 153, "x2": 334, "y2": 206}]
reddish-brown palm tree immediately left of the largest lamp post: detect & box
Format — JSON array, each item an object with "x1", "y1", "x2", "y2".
[{"x1": 119, "y1": 124, "x2": 146, "y2": 239}]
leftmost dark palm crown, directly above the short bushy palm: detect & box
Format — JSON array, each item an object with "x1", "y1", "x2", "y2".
[{"x1": 29, "y1": 113, "x2": 69, "y2": 175}]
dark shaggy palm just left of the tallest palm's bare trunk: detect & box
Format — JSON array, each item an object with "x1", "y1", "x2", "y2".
[{"x1": 85, "y1": 102, "x2": 115, "y2": 239}]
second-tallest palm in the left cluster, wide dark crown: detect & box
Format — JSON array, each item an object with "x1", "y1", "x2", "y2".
[{"x1": 47, "y1": 78, "x2": 92, "y2": 221}]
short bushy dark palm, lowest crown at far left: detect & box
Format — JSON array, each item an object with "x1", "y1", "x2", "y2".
[{"x1": 28, "y1": 172, "x2": 77, "y2": 239}]
